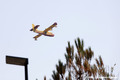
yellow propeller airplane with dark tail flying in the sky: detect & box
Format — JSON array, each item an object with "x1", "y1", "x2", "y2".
[{"x1": 30, "y1": 22, "x2": 57, "y2": 40}]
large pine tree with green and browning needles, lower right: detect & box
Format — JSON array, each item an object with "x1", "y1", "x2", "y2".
[{"x1": 44, "y1": 38, "x2": 113, "y2": 80}]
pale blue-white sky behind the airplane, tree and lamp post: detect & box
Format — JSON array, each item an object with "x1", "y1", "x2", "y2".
[{"x1": 0, "y1": 0, "x2": 120, "y2": 80}]
